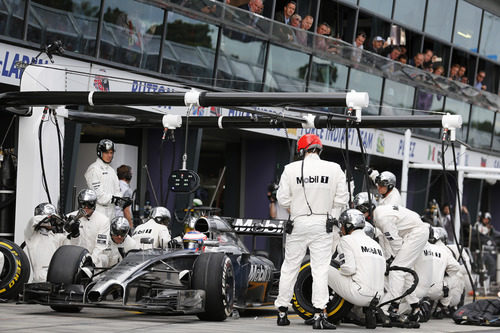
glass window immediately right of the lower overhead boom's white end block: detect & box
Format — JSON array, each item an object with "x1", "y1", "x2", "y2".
[{"x1": 467, "y1": 106, "x2": 495, "y2": 149}]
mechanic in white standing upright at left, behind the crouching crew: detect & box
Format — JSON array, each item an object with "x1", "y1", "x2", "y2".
[{"x1": 85, "y1": 139, "x2": 132, "y2": 220}]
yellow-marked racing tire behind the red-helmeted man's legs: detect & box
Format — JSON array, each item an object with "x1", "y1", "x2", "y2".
[{"x1": 292, "y1": 261, "x2": 352, "y2": 323}]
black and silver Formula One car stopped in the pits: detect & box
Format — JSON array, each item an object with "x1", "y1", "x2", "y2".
[{"x1": 24, "y1": 216, "x2": 279, "y2": 321}]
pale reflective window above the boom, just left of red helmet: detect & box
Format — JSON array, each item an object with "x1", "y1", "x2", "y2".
[{"x1": 264, "y1": 44, "x2": 309, "y2": 91}]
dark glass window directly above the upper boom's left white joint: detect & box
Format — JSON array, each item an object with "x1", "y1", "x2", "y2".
[{"x1": 161, "y1": 12, "x2": 218, "y2": 84}]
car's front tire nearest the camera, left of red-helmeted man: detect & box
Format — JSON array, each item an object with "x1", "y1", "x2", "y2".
[{"x1": 192, "y1": 252, "x2": 235, "y2": 321}]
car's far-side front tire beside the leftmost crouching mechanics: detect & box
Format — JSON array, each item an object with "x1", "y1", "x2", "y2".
[{"x1": 47, "y1": 245, "x2": 91, "y2": 313}]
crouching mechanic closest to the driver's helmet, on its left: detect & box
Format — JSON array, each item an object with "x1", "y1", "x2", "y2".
[{"x1": 132, "y1": 207, "x2": 170, "y2": 249}]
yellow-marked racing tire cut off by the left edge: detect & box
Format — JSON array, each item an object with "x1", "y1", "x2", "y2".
[{"x1": 0, "y1": 238, "x2": 31, "y2": 299}]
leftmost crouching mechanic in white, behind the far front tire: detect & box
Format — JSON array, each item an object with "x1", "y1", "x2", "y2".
[{"x1": 24, "y1": 203, "x2": 70, "y2": 282}]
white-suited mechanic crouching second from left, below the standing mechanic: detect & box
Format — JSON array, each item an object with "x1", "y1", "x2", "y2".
[{"x1": 64, "y1": 189, "x2": 110, "y2": 266}]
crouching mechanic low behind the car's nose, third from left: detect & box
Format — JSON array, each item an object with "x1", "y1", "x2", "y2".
[{"x1": 92, "y1": 216, "x2": 138, "y2": 268}]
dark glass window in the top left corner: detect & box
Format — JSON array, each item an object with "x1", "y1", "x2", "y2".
[{"x1": 0, "y1": 0, "x2": 26, "y2": 39}]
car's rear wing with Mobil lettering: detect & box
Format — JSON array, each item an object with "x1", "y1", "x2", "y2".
[{"x1": 224, "y1": 217, "x2": 286, "y2": 236}]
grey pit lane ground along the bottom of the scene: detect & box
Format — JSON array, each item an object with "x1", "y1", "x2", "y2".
[{"x1": 0, "y1": 303, "x2": 500, "y2": 333}]
